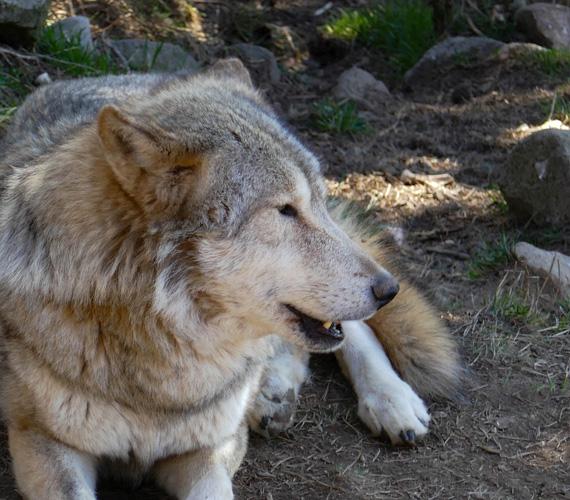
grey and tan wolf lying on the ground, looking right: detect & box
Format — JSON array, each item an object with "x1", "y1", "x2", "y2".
[{"x1": 0, "y1": 59, "x2": 459, "y2": 500}]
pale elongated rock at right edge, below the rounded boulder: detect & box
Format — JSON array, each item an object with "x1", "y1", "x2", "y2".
[{"x1": 515, "y1": 241, "x2": 570, "y2": 297}]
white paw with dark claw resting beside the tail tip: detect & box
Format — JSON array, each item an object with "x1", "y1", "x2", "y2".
[{"x1": 358, "y1": 380, "x2": 430, "y2": 444}]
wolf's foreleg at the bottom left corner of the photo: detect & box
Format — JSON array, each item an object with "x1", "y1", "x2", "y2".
[{"x1": 8, "y1": 425, "x2": 96, "y2": 500}]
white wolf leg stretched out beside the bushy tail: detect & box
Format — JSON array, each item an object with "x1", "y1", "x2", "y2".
[{"x1": 337, "y1": 321, "x2": 430, "y2": 444}]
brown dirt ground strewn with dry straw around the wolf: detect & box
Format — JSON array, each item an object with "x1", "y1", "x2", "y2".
[{"x1": 0, "y1": 0, "x2": 570, "y2": 500}]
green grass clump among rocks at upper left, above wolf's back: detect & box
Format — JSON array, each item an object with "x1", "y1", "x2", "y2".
[{"x1": 37, "y1": 26, "x2": 118, "y2": 77}]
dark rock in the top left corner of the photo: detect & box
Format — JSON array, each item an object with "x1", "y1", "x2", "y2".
[{"x1": 0, "y1": 0, "x2": 50, "y2": 46}]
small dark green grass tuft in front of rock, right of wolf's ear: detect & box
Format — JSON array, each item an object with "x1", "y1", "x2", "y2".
[{"x1": 313, "y1": 99, "x2": 370, "y2": 135}]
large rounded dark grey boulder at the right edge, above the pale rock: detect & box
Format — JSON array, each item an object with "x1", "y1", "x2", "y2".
[{"x1": 498, "y1": 129, "x2": 570, "y2": 225}]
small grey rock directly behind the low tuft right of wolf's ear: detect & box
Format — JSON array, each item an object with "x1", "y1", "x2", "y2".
[{"x1": 333, "y1": 67, "x2": 391, "y2": 110}]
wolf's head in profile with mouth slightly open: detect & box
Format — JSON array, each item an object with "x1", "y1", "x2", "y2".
[{"x1": 98, "y1": 60, "x2": 398, "y2": 351}]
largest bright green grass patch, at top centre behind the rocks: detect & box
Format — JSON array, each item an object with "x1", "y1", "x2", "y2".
[{"x1": 323, "y1": 0, "x2": 436, "y2": 74}]
